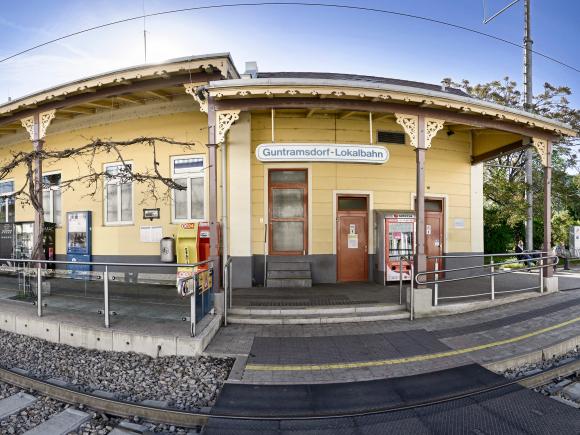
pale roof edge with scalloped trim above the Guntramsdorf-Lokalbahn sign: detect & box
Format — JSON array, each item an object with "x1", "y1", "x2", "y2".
[{"x1": 208, "y1": 78, "x2": 576, "y2": 136}]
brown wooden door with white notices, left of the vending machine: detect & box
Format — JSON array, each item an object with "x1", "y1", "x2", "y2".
[{"x1": 336, "y1": 197, "x2": 368, "y2": 282}]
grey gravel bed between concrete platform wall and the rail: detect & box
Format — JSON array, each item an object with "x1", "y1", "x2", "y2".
[{"x1": 0, "y1": 331, "x2": 234, "y2": 411}]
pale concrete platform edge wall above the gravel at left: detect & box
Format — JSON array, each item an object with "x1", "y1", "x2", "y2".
[{"x1": 0, "y1": 306, "x2": 222, "y2": 358}]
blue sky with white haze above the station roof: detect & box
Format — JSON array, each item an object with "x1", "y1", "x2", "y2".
[{"x1": 0, "y1": 0, "x2": 580, "y2": 106}]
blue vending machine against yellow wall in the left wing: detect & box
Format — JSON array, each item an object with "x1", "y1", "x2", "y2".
[{"x1": 66, "y1": 211, "x2": 92, "y2": 279}]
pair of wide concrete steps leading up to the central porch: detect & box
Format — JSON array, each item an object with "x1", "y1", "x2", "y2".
[{"x1": 228, "y1": 304, "x2": 409, "y2": 325}]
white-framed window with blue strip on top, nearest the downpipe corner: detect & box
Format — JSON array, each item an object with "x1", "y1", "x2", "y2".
[{"x1": 171, "y1": 156, "x2": 205, "y2": 221}]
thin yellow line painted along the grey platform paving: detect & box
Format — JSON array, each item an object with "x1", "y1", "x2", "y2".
[{"x1": 245, "y1": 317, "x2": 580, "y2": 372}]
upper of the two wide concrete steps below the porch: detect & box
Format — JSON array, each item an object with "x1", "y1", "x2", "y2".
[{"x1": 228, "y1": 304, "x2": 405, "y2": 317}]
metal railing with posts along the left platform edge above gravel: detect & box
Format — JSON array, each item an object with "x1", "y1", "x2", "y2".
[{"x1": 0, "y1": 258, "x2": 214, "y2": 336}]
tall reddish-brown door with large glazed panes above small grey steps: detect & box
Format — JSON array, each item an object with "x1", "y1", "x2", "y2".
[{"x1": 268, "y1": 169, "x2": 308, "y2": 255}]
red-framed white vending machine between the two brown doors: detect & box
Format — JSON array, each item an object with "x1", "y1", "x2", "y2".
[{"x1": 375, "y1": 210, "x2": 415, "y2": 284}]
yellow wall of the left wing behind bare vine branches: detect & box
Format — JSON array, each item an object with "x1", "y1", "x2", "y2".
[{"x1": 0, "y1": 111, "x2": 221, "y2": 256}]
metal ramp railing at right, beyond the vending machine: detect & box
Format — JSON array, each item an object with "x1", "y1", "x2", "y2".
[{"x1": 411, "y1": 251, "x2": 559, "y2": 306}]
